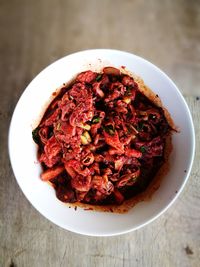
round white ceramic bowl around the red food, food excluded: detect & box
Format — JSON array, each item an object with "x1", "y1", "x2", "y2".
[{"x1": 9, "y1": 49, "x2": 195, "y2": 236}]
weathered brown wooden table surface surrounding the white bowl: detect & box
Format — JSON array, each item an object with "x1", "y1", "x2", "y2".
[{"x1": 0, "y1": 0, "x2": 200, "y2": 267}]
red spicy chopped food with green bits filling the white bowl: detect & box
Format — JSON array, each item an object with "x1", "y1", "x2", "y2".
[{"x1": 32, "y1": 67, "x2": 174, "y2": 211}]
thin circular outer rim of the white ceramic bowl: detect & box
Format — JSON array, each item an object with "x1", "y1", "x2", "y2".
[{"x1": 8, "y1": 48, "x2": 196, "y2": 237}]
